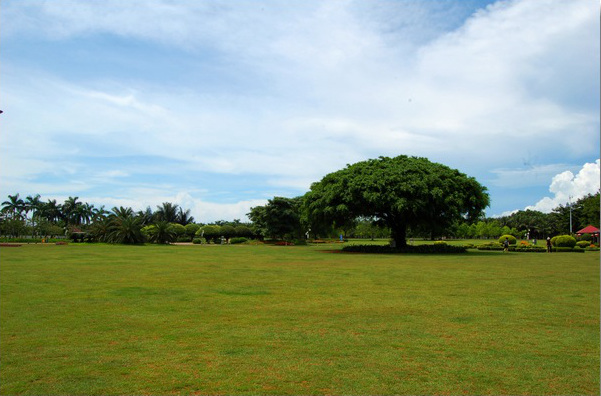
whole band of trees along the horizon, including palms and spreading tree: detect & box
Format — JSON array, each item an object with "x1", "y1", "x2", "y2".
[{"x1": 0, "y1": 156, "x2": 599, "y2": 246}]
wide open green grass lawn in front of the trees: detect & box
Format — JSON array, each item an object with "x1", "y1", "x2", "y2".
[{"x1": 0, "y1": 244, "x2": 599, "y2": 395}]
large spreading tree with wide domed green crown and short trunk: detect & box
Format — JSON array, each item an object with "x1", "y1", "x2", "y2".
[{"x1": 305, "y1": 155, "x2": 489, "y2": 247}]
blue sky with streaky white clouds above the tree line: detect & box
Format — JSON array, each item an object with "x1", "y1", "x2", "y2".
[{"x1": 0, "y1": 0, "x2": 600, "y2": 222}]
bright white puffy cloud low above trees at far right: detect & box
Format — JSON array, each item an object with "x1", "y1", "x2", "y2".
[{"x1": 526, "y1": 160, "x2": 600, "y2": 213}]
